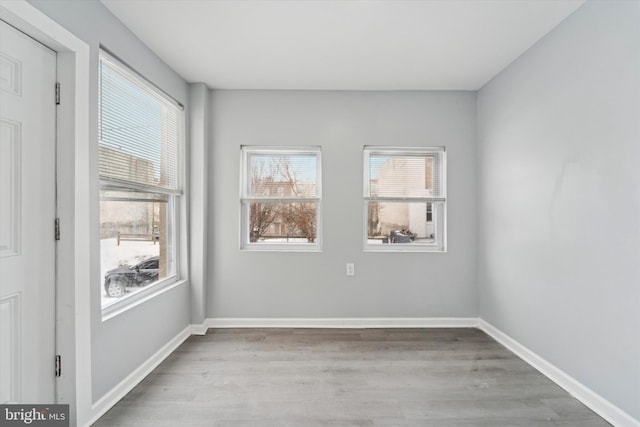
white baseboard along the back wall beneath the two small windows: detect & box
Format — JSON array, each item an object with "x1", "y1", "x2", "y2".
[{"x1": 203, "y1": 317, "x2": 478, "y2": 330}]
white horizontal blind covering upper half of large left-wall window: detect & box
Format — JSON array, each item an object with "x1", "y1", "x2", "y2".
[{"x1": 98, "y1": 51, "x2": 182, "y2": 194}]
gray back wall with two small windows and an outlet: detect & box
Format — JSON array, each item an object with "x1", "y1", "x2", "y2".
[{"x1": 207, "y1": 90, "x2": 478, "y2": 318}]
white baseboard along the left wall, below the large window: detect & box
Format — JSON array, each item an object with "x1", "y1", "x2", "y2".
[{"x1": 87, "y1": 326, "x2": 191, "y2": 425}]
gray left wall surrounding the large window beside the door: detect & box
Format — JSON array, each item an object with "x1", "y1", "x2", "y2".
[{"x1": 32, "y1": 0, "x2": 189, "y2": 402}]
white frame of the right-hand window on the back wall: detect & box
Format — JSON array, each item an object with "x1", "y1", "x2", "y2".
[{"x1": 362, "y1": 146, "x2": 447, "y2": 252}]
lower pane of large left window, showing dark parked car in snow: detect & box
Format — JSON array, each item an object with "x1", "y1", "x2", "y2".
[{"x1": 100, "y1": 190, "x2": 175, "y2": 307}]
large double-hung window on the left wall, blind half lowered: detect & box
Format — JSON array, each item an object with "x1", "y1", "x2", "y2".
[{"x1": 98, "y1": 51, "x2": 184, "y2": 313}]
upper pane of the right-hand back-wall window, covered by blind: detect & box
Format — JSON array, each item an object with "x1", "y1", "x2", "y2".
[{"x1": 369, "y1": 153, "x2": 441, "y2": 197}]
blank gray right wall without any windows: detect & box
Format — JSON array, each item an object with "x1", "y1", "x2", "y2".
[{"x1": 478, "y1": 1, "x2": 640, "y2": 419}]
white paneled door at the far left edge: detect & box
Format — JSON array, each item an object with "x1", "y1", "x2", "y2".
[{"x1": 0, "y1": 21, "x2": 56, "y2": 403}]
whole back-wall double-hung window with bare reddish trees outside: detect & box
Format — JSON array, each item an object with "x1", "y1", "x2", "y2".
[{"x1": 240, "y1": 146, "x2": 322, "y2": 250}]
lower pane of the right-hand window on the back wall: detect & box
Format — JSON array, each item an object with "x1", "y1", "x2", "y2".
[{"x1": 367, "y1": 201, "x2": 437, "y2": 245}]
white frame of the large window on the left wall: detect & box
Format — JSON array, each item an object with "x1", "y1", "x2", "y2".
[{"x1": 99, "y1": 48, "x2": 186, "y2": 321}]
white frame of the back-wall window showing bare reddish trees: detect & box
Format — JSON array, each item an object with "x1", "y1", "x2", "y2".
[{"x1": 239, "y1": 145, "x2": 322, "y2": 252}]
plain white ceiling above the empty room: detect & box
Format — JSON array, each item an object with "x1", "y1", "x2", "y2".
[{"x1": 102, "y1": 0, "x2": 584, "y2": 90}]
